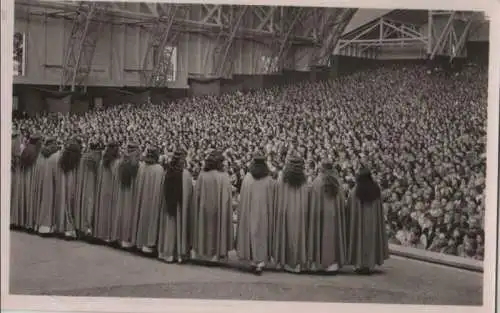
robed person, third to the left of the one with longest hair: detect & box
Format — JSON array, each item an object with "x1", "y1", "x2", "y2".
[{"x1": 92, "y1": 142, "x2": 120, "y2": 242}]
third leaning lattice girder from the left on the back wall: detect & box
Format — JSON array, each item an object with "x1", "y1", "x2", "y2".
[{"x1": 214, "y1": 5, "x2": 249, "y2": 77}]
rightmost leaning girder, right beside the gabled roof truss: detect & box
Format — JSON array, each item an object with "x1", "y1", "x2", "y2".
[{"x1": 313, "y1": 9, "x2": 356, "y2": 65}]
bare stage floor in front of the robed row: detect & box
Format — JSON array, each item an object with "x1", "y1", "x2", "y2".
[{"x1": 10, "y1": 231, "x2": 483, "y2": 305}]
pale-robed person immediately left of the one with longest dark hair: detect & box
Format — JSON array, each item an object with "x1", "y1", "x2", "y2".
[{"x1": 135, "y1": 147, "x2": 164, "y2": 253}]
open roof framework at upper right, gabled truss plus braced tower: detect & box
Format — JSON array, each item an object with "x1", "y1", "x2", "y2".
[{"x1": 335, "y1": 10, "x2": 484, "y2": 60}]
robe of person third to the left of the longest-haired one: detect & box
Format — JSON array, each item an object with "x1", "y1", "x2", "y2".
[{"x1": 93, "y1": 159, "x2": 118, "y2": 242}]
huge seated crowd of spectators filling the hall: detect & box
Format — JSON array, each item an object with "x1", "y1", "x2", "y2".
[{"x1": 13, "y1": 65, "x2": 487, "y2": 260}]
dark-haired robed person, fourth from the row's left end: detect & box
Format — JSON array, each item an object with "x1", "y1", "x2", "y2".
[{"x1": 54, "y1": 139, "x2": 82, "y2": 238}]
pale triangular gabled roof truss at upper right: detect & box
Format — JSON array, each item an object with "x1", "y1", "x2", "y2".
[{"x1": 334, "y1": 17, "x2": 427, "y2": 56}]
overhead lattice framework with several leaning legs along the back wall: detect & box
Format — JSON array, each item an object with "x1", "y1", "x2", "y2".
[{"x1": 16, "y1": 0, "x2": 356, "y2": 85}]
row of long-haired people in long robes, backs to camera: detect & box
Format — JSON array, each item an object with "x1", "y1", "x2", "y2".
[{"x1": 11, "y1": 139, "x2": 389, "y2": 274}]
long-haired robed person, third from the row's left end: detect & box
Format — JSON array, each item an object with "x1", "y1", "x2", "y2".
[{"x1": 31, "y1": 137, "x2": 59, "y2": 232}]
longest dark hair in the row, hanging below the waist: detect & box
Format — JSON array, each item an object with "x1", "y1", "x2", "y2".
[{"x1": 163, "y1": 151, "x2": 186, "y2": 217}]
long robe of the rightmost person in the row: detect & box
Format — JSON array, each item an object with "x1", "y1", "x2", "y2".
[{"x1": 346, "y1": 187, "x2": 389, "y2": 270}]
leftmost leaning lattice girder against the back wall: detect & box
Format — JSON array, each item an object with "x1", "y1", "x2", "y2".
[{"x1": 59, "y1": 2, "x2": 109, "y2": 91}]
